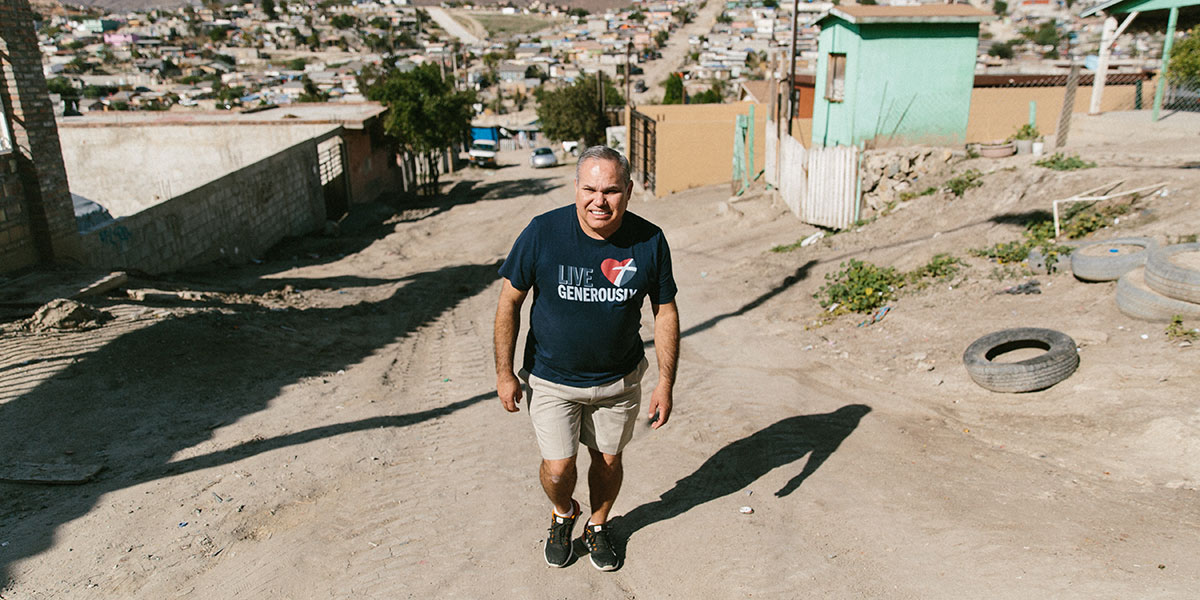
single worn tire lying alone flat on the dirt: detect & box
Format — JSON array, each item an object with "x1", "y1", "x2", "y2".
[{"x1": 962, "y1": 328, "x2": 1079, "y2": 392}]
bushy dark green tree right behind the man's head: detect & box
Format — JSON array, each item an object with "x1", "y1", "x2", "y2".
[{"x1": 535, "y1": 77, "x2": 625, "y2": 146}]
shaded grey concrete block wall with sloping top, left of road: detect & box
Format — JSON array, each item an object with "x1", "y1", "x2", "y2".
[{"x1": 80, "y1": 139, "x2": 325, "y2": 274}]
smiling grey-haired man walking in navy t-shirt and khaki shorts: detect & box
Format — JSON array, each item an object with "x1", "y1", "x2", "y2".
[{"x1": 496, "y1": 146, "x2": 679, "y2": 571}]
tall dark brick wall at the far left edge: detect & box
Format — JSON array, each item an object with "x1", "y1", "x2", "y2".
[{"x1": 0, "y1": 0, "x2": 78, "y2": 271}]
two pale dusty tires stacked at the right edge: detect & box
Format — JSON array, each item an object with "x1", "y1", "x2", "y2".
[{"x1": 1117, "y1": 244, "x2": 1200, "y2": 322}]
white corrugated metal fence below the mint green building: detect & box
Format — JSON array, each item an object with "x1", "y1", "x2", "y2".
[{"x1": 766, "y1": 121, "x2": 859, "y2": 229}]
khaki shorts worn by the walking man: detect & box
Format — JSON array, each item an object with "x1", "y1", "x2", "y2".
[{"x1": 517, "y1": 359, "x2": 649, "y2": 461}]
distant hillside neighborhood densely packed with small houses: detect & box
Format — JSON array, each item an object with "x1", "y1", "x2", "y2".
[{"x1": 28, "y1": 0, "x2": 1180, "y2": 114}]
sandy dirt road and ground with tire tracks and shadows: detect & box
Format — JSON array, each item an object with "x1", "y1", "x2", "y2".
[{"x1": 0, "y1": 111, "x2": 1200, "y2": 599}]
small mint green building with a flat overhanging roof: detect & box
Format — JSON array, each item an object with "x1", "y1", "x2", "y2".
[{"x1": 812, "y1": 5, "x2": 994, "y2": 148}]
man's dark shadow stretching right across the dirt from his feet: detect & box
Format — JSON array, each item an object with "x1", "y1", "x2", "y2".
[{"x1": 612, "y1": 404, "x2": 871, "y2": 554}]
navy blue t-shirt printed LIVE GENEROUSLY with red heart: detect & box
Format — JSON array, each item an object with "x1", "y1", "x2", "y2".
[{"x1": 500, "y1": 204, "x2": 676, "y2": 388}]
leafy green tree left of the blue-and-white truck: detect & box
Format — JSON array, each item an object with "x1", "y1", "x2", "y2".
[{"x1": 359, "y1": 62, "x2": 475, "y2": 190}]
